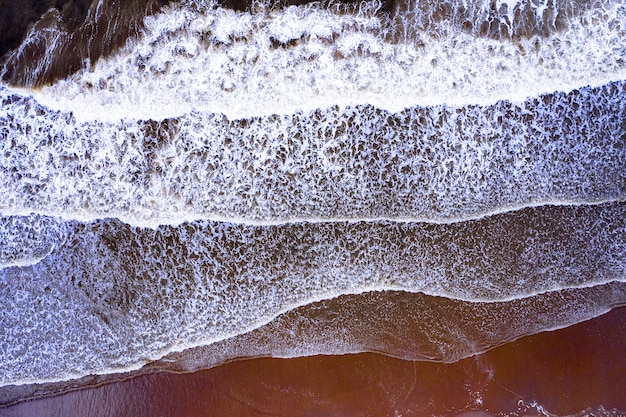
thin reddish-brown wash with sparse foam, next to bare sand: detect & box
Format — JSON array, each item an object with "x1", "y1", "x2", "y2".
[{"x1": 152, "y1": 283, "x2": 626, "y2": 372}]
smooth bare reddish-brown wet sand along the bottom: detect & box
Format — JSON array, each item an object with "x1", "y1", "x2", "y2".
[{"x1": 0, "y1": 308, "x2": 626, "y2": 417}]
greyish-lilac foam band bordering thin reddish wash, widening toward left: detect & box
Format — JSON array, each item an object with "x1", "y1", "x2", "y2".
[{"x1": 0, "y1": 203, "x2": 626, "y2": 384}]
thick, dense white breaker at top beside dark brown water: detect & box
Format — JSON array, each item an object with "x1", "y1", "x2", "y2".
[{"x1": 24, "y1": 2, "x2": 626, "y2": 121}]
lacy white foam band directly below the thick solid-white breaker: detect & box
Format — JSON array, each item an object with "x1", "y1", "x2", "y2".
[{"x1": 0, "y1": 82, "x2": 626, "y2": 227}]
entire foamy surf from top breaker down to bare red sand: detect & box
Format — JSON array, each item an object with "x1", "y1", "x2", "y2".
[{"x1": 0, "y1": 0, "x2": 626, "y2": 406}]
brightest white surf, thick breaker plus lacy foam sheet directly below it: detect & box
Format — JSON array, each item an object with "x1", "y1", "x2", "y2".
[{"x1": 0, "y1": 2, "x2": 626, "y2": 227}]
